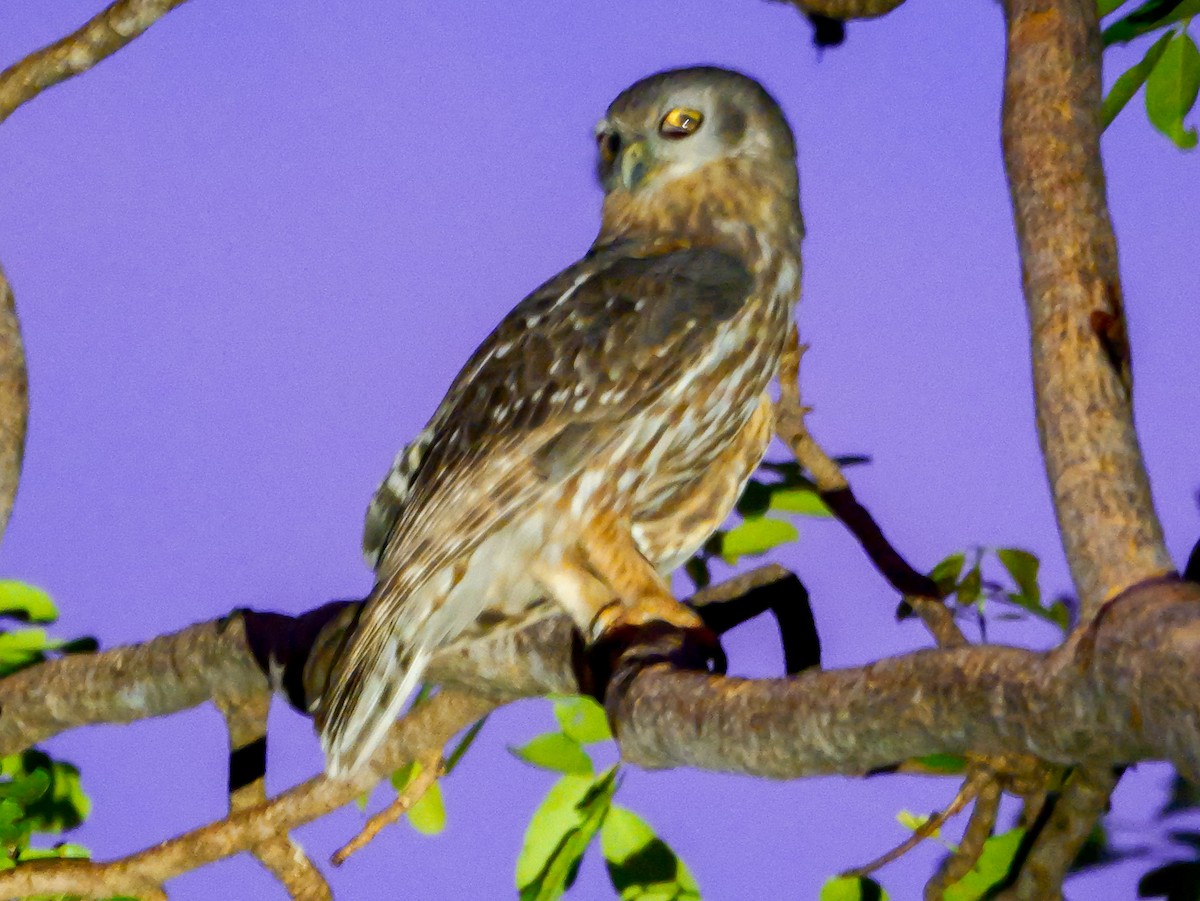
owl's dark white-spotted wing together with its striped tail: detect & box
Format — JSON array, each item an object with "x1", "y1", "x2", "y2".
[{"x1": 318, "y1": 248, "x2": 752, "y2": 773}]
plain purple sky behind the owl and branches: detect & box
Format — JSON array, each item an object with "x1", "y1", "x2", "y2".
[{"x1": 0, "y1": 0, "x2": 1200, "y2": 901}]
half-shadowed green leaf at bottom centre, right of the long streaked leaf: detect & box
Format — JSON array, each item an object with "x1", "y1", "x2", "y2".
[{"x1": 600, "y1": 804, "x2": 700, "y2": 901}]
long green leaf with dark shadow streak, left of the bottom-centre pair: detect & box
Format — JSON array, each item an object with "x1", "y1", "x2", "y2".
[{"x1": 516, "y1": 767, "x2": 617, "y2": 901}]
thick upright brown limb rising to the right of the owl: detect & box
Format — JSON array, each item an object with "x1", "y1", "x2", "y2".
[{"x1": 1003, "y1": 0, "x2": 1174, "y2": 623}]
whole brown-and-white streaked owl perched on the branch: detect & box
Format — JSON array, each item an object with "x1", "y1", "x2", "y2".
[{"x1": 316, "y1": 67, "x2": 804, "y2": 776}]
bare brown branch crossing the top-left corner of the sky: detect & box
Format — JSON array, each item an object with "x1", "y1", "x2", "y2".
[{"x1": 0, "y1": 0, "x2": 185, "y2": 122}]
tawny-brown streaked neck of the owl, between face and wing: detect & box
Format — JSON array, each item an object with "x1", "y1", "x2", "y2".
[{"x1": 595, "y1": 160, "x2": 804, "y2": 269}]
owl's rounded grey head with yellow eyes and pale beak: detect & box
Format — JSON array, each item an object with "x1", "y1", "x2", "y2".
[{"x1": 596, "y1": 66, "x2": 796, "y2": 194}]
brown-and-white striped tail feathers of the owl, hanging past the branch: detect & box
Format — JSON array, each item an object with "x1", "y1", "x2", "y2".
[{"x1": 316, "y1": 601, "x2": 430, "y2": 779}]
